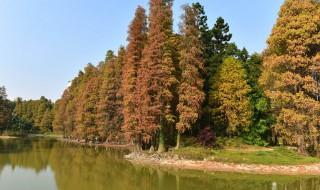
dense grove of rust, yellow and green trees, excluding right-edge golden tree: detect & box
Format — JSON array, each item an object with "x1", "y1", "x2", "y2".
[{"x1": 53, "y1": 0, "x2": 273, "y2": 152}]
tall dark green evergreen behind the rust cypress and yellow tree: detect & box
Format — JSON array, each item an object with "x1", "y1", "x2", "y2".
[{"x1": 192, "y1": 3, "x2": 234, "y2": 129}]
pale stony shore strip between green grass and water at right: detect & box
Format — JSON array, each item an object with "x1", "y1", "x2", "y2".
[{"x1": 125, "y1": 153, "x2": 320, "y2": 175}]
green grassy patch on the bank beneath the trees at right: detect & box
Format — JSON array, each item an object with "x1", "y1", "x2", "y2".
[{"x1": 166, "y1": 137, "x2": 320, "y2": 165}]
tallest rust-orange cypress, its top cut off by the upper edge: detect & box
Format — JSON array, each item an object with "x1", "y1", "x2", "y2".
[{"x1": 138, "y1": 0, "x2": 177, "y2": 152}]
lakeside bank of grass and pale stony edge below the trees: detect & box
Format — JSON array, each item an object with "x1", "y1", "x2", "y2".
[{"x1": 27, "y1": 139, "x2": 320, "y2": 175}]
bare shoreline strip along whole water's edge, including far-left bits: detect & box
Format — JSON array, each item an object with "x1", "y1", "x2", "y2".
[{"x1": 5, "y1": 135, "x2": 320, "y2": 176}]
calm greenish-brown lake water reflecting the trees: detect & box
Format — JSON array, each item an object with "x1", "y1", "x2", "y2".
[{"x1": 0, "y1": 138, "x2": 320, "y2": 190}]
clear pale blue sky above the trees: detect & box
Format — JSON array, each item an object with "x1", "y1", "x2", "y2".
[{"x1": 0, "y1": 0, "x2": 284, "y2": 101}]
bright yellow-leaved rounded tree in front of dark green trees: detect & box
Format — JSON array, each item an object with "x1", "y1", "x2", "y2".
[{"x1": 210, "y1": 57, "x2": 252, "y2": 136}]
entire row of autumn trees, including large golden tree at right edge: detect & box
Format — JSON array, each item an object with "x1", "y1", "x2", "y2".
[{"x1": 0, "y1": 0, "x2": 320, "y2": 154}]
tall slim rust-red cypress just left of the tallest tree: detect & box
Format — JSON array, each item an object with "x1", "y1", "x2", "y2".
[{"x1": 122, "y1": 6, "x2": 147, "y2": 148}]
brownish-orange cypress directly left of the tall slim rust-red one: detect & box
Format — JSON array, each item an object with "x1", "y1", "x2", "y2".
[{"x1": 97, "y1": 47, "x2": 126, "y2": 140}]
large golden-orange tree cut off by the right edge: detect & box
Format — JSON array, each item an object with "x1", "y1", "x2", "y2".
[{"x1": 260, "y1": 0, "x2": 320, "y2": 154}]
